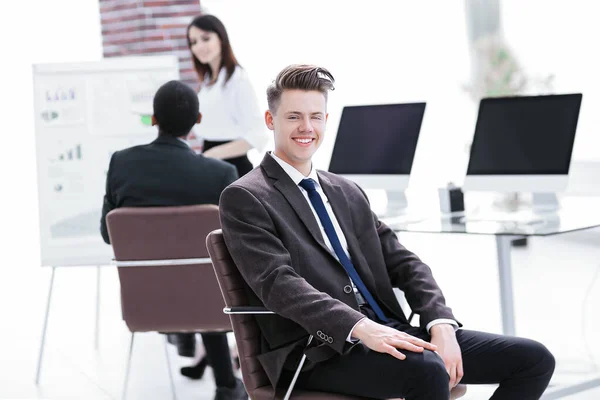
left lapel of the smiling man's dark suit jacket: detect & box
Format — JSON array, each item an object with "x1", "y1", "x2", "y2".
[{"x1": 260, "y1": 153, "x2": 329, "y2": 253}]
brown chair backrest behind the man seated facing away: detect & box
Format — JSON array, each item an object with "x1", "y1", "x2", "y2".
[{"x1": 106, "y1": 205, "x2": 231, "y2": 332}]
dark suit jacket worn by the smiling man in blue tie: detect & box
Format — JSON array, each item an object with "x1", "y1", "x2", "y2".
[{"x1": 220, "y1": 154, "x2": 454, "y2": 386}]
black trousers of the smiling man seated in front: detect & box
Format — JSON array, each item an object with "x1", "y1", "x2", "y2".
[{"x1": 296, "y1": 312, "x2": 555, "y2": 400}]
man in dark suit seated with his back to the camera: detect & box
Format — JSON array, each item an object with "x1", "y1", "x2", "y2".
[{"x1": 100, "y1": 81, "x2": 247, "y2": 400}]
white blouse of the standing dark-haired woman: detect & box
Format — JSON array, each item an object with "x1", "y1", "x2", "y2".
[{"x1": 194, "y1": 66, "x2": 269, "y2": 152}]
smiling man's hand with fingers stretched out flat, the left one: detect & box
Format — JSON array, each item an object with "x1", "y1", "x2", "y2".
[{"x1": 352, "y1": 318, "x2": 437, "y2": 360}]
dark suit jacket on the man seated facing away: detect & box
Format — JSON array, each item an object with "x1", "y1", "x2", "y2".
[{"x1": 100, "y1": 136, "x2": 237, "y2": 243}]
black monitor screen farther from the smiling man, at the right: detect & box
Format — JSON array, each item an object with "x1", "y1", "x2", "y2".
[{"x1": 467, "y1": 94, "x2": 582, "y2": 175}]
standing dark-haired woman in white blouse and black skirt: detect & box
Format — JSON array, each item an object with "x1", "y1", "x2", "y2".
[{"x1": 187, "y1": 15, "x2": 268, "y2": 177}]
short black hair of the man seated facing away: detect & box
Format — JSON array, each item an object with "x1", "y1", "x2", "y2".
[{"x1": 153, "y1": 81, "x2": 200, "y2": 137}]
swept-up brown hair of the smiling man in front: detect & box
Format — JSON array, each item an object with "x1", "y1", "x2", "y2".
[{"x1": 267, "y1": 64, "x2": 335, "y2": 114}]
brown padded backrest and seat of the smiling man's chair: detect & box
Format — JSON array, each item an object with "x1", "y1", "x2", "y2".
[{"x1": 206, "y1": 229, "x2": 366, "y2": 400}]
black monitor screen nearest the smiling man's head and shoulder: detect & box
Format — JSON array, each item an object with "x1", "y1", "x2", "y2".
[{"x1": 329, "y1": 103, "x2": 425, "y2": 175}]
